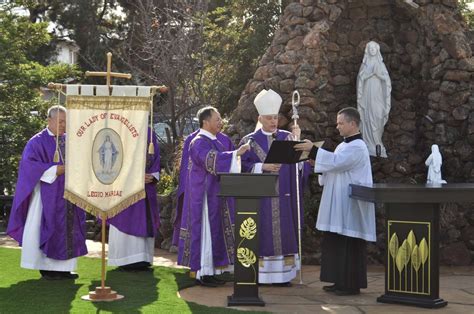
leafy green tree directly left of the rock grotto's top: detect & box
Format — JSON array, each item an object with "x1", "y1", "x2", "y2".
[{"x1": 203, "y1": 0, "x2": 281, "y2": 113}]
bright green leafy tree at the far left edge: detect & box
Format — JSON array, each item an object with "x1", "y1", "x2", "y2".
[{"x1": 0, "y1": 10, "x2": 79, "y2": 194}]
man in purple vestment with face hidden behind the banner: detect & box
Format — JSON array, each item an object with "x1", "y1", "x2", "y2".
[{"x1": 108, "y1": 128, "x2": 160, "y2": 271}]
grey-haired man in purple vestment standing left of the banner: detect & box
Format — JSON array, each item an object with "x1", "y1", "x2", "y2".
[{"x1": 7, "y1": 106, "x2": 87, "y2": 280}]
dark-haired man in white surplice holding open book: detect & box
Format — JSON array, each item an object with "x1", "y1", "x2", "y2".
[{"x1": 295, "y1": 107, "x2": 376, "y2": 295}]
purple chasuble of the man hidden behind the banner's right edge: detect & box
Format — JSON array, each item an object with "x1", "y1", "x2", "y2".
[{"x1": 108, "y1": 128, "x2": 160, "y2": 238}]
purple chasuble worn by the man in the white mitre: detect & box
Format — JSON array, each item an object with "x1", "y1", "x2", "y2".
[{"x1": 241, "y1": 129, "x2": 310, "y2": 256}]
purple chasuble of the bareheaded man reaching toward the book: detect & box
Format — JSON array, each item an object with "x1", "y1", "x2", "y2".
[{"x1": 178, "y1": 134, "x2": 234, "y2": 271}]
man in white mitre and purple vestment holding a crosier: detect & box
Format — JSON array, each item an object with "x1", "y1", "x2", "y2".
[{"x1": 241, "y1": 89, "x2": 310, "y2": 286}]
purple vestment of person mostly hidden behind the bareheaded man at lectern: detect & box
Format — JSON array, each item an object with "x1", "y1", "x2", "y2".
[{"x1": 171, "y1": 130, "x2": 234, "y2": 246}]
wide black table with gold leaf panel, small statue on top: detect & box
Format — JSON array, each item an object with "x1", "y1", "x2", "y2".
[{"x1": 351, "y1": 183, "x2": 474, "y2": 308}]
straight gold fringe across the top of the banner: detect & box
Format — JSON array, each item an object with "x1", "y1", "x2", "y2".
[{"x1": 66, "y1": 95, "x2": 150, "y2": 111}]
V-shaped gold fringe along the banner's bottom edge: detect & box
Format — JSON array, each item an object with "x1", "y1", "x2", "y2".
[{"x1": 64, "y1": 190, "x2": 146, "y2": 218}]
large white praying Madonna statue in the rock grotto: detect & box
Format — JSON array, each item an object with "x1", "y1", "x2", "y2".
[{"x1": 357, "y1": 41, "x2": 392, "y2": 158}]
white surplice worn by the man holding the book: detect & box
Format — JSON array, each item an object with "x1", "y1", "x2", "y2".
[{"x1": 314, "y1": 139, "x2": 376, "y2": 242}]
